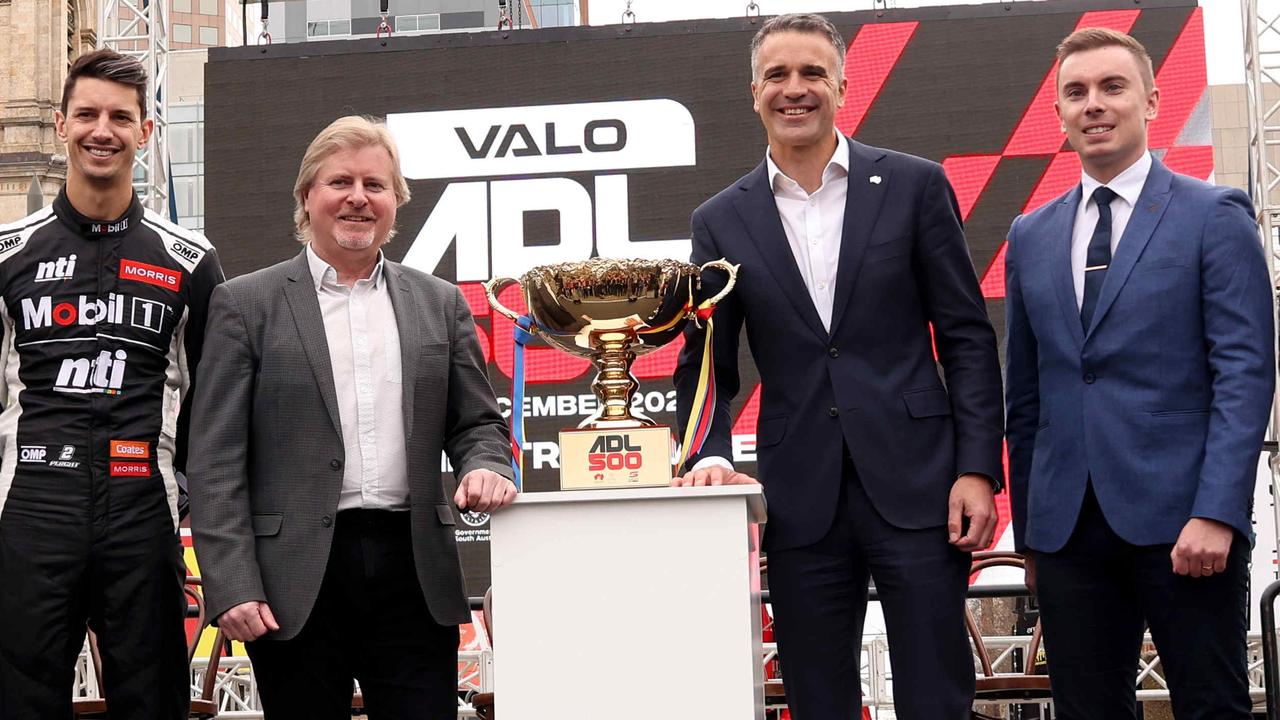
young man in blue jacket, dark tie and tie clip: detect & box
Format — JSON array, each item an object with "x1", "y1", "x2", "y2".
[{"x1": 1006, "y1": 28, "x2": 1275, "y2": 720}]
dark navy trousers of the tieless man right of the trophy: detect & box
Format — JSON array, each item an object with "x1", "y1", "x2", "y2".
[{"x1": 769, "y1": 457, "x2": 974, "y2": 720}]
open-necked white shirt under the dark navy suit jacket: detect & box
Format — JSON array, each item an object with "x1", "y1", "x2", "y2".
[{"x1": 764, "y1": 132, "x2": 849, "y2": 331}]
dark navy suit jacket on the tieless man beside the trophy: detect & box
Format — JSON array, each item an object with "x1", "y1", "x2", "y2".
[{"x1": 675, "y1": 141, "x2": 1002, "y2": 550}]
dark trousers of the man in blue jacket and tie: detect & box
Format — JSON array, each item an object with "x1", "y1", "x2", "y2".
[{"x1": 1036, "y1": 486, "x2": 1251, "y2": 720}]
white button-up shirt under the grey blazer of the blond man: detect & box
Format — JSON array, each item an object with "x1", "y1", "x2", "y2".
[{"x1": 306, "y1": 245, "x2": 408, "y2": 510}]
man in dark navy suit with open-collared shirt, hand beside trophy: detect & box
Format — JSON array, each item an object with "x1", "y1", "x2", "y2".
[{"x1": 675, "y1": 15, "x2": 1002, "y2": 720}]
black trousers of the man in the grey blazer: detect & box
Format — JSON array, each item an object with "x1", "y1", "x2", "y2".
[{"x1": 246, "y1": 510, "x2": 458, "y2": 720}]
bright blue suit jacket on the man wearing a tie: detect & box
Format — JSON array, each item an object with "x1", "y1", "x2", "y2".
[{"x1": 1005, "y1": 160, "x2": 1275, "y2": 552}]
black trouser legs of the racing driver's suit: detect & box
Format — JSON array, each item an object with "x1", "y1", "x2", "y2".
[{"x1": 0, "y1": 493, "x2": 191, "y2": 720}]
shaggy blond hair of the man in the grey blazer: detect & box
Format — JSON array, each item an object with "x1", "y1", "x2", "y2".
[{"x1": 293, "y1": 115, "x2": 410, "y2": 243}]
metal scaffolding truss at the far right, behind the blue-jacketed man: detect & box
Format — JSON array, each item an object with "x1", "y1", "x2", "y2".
[{"x1": 1240, "y1": 0, "x2": 1280, "y2": 540}]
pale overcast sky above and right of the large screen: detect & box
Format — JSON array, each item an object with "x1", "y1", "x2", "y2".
[{"x1": 590, "y1": 0, "x2": 1249, "y2": 85}]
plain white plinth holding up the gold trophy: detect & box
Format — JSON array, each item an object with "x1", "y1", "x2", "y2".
[{"x1": 490, "y1": 486, "x2": 764, "y2": 720}]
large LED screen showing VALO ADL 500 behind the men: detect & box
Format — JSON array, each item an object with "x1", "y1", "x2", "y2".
[{"x1": 205, "y1": 0, "x2": 1213, "y2": 594}]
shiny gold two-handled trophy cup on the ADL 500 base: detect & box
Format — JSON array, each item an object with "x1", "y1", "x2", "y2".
[{"x1": 484, "y1": 258, "x2": 737, "y2": 429}]
